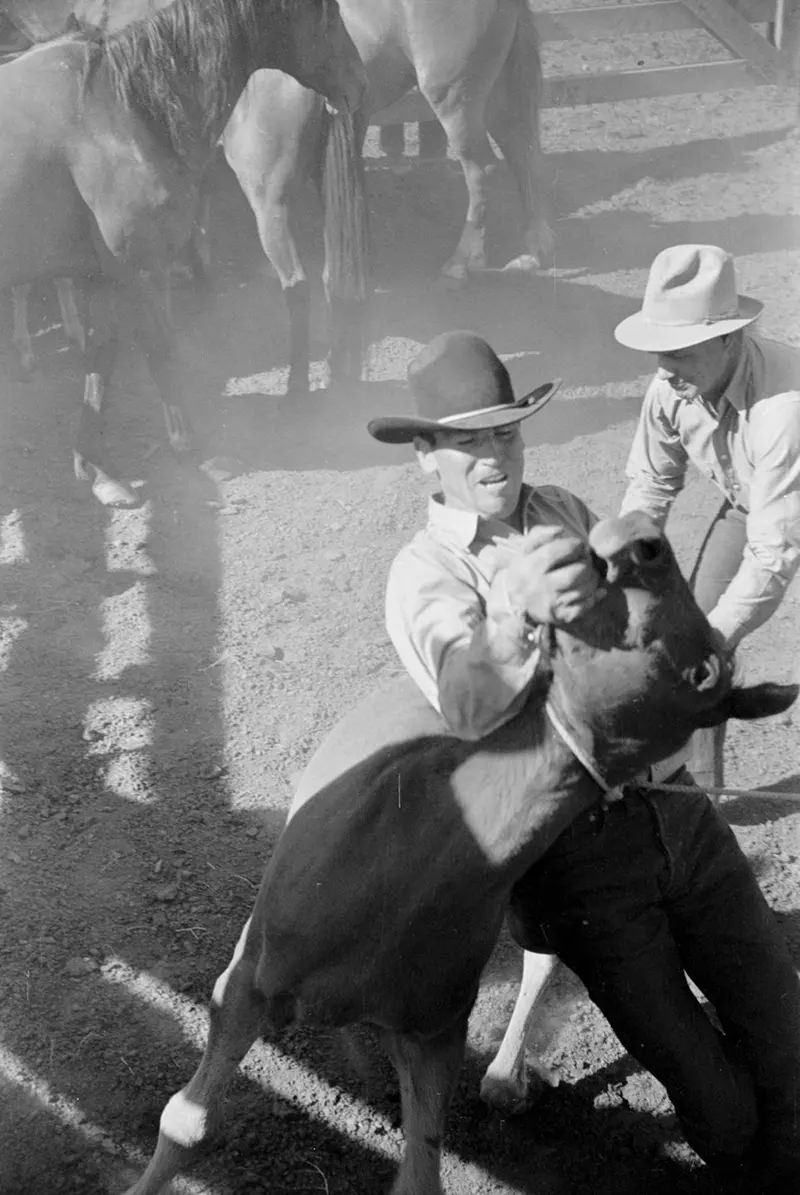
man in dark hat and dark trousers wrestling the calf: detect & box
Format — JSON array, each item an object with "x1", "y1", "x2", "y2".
[{"x1": 370, "y1": 332, "x2": 800, "y2": 1195}]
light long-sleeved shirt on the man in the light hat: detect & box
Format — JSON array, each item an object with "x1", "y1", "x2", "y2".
[{"x1": 621, "y1": 336, "x2": 800, "y2": 646}]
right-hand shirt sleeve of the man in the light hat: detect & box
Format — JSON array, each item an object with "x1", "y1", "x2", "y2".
[{"x1": 709, "y1": 392, "x2": 800, "y2": 646}]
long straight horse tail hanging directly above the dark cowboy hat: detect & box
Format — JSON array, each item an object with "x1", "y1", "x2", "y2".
[{"x1": 320, "y1": 110, "x2": 371, "y2": 380}]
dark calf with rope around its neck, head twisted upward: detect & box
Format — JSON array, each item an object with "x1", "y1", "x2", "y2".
[{"x1": 121, "y1": 513, "x2": 798, "y2": 1195}]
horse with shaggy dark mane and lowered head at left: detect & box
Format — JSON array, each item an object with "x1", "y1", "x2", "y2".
[{"x1": 0, "y1": 0, "x2": 366, "y2": 505}]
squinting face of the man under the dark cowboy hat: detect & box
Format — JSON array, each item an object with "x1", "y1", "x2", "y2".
[{"x1": 414, "y1": 423, "x2": 524, "y2": 520}]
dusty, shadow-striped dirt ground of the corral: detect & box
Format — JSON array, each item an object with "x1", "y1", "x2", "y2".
[{"x1": 0, "y1": 21, "x2": 800, "y2": 1195}]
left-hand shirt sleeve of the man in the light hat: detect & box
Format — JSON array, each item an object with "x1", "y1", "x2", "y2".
[{"x1": 619, "y1": 378, "x2": 689, "y2": 527}]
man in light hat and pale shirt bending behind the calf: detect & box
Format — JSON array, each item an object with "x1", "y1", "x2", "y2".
[{"x1": 615, "y1": 245, "x2": 800, "y2": 786}]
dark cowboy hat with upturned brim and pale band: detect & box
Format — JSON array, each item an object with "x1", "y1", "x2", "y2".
[{"x1": 367, "y1": 332, "x2": 561, "y2": 445}]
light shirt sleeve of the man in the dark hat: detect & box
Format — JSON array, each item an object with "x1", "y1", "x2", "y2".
[{"x1": 386, "y1": 543, "x2": 538, "y2": 740}]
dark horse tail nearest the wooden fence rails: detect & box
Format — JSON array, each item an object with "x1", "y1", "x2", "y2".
[{"x1": 493, "y1": 0, "x2": 552, "y2": 257}]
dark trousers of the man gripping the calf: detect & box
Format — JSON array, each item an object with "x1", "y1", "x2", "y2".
[{"x1": 509, "y1": 770, "x2": 800, "y2": 1175}]
